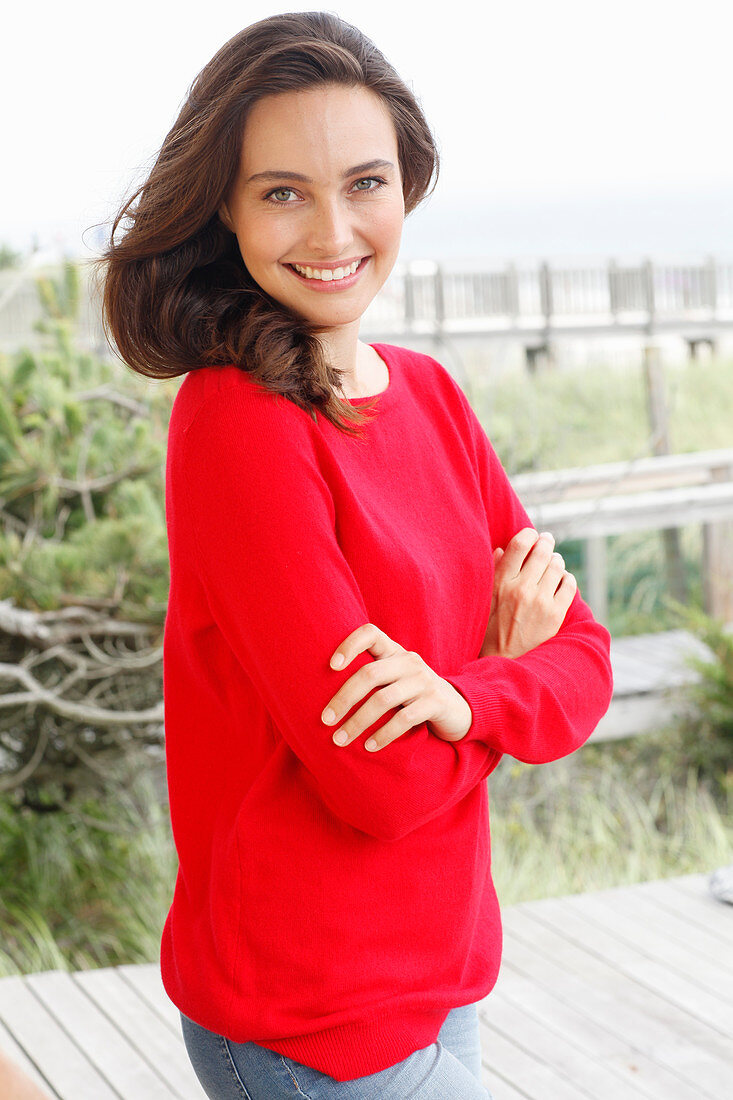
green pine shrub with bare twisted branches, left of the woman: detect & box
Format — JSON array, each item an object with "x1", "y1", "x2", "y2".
[{"x1": 0, "y1": 263, "x2": 173, "y2": 811}]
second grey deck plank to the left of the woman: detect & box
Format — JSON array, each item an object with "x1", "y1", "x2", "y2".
[{"x1": 74, "y1": 967, "x2": 203, "y2": 1100}]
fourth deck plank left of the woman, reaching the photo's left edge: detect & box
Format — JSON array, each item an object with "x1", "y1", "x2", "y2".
[{"x1": 0, "y1": 977, "x2": 118, "y2": 1100}]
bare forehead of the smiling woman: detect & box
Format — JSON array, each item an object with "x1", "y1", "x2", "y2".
[{"x1": 241, "y1": 85, "x2": 397, "y2": 176}]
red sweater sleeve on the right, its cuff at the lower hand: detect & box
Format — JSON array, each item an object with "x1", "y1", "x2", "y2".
[{"x1": 444, "y1": 384, "x2": 613, "y2": 763}]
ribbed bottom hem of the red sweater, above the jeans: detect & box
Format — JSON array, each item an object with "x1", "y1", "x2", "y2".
[{"x1": 258, "y1": 1009, "x2": 449, "y2": 1081}]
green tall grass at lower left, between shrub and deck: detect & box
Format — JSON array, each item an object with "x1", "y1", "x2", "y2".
[{"x1": 0, "y1": 772, "x2": 177, "y2": 975}]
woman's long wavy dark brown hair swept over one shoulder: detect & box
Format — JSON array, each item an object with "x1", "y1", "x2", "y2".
[{"x1": 90, "y1": 11, "x2": 440, "y2": 435}]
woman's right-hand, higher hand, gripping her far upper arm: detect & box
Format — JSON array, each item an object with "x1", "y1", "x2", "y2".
[{"x1": 479, "y1": 527, "x2": 578, "y2": 657}]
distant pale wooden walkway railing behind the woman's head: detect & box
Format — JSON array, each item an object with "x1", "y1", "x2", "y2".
[{"x1": 0, "y1": 256, "x2": 733, "y2": 363}]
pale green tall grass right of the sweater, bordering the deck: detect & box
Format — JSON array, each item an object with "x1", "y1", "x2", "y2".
[{"x1": 482, "y1": 738, "x2": 733, "y2": 905}]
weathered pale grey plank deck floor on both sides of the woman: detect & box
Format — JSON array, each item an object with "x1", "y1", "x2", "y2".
[{"x1": 0, "y1": 875, "x2": 733, "y2": 1100}]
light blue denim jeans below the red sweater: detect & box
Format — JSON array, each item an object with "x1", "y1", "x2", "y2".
[{"x1": 180, "y1": 1004, "x2": 492, "y2": 1100}]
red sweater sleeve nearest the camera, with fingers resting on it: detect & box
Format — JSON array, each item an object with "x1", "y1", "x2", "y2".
[{"x1": 176, "y1": 387, "x2": 501, "y2": 840}]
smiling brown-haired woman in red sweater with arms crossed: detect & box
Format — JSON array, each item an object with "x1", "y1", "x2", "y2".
[{"x1": 95, "y1": 12, "x2": 611, "y2": 1100}]
